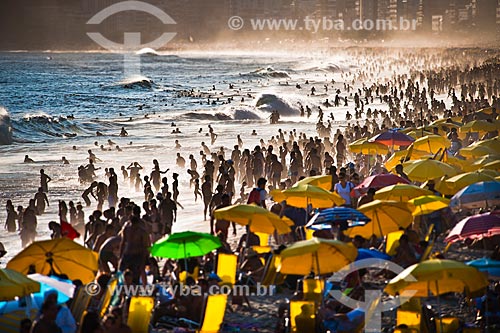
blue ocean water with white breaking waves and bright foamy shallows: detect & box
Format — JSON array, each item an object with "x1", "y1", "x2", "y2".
[{"x1": 0, "y1": 52, "x2": 384, "y2": 264}]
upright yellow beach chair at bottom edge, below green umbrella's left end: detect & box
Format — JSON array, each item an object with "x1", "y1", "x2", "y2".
[{"x1": 127, "y1": 296, "x2": 155, "y2": 333}]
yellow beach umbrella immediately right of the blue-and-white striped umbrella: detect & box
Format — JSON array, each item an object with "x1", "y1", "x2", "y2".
[{"x1": 345, "y1": 200, "x2": 413, "y2": 239}]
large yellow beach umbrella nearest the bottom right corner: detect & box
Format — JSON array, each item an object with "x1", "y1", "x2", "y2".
[{"x1": 385, "y1": 259, "x2": 488, "y2": 297}]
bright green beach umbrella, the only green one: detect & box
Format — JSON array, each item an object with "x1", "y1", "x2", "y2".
[{"x1": 149, "y1": 231, "x2": 222, "y2": 259}]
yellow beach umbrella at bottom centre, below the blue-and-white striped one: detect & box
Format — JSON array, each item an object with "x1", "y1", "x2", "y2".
[{"x1": 278, "y1": 238, "x2": 358, "y2": 275}]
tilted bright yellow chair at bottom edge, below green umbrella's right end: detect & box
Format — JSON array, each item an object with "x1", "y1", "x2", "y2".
[{"x1": 198, "y1": 294, "x2": 227, "y2": 333}]
